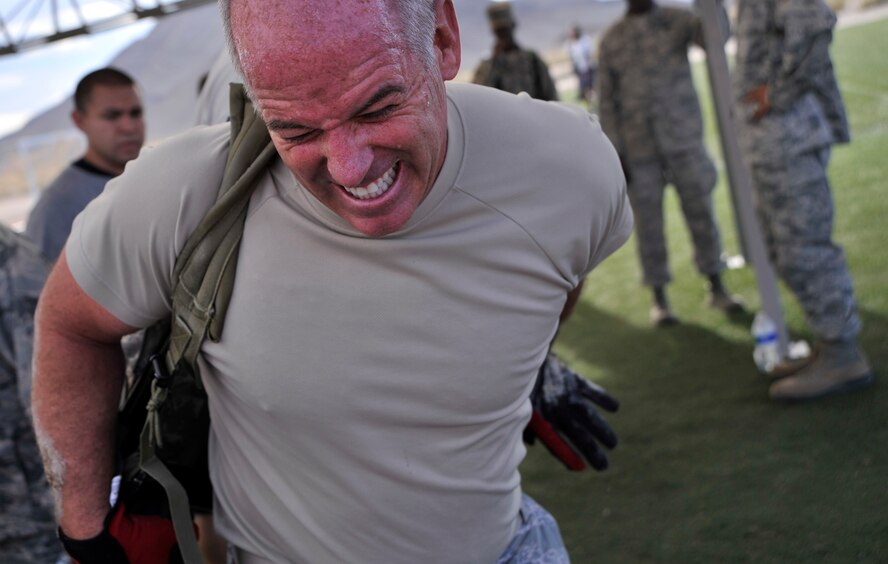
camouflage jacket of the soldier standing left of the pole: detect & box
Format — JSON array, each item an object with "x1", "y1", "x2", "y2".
[{"x1": 598, "y1": 6, "x2": 727, "y2": 161}]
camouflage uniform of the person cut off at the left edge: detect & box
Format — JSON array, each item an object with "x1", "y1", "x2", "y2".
[{"x1": 0, "y1": 225, "x2": 62, "y2": 564}]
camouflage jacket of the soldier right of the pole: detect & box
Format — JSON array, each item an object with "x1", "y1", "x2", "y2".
[{"x1": 734, "y1": 0, "x2": 850, "y2": 143}]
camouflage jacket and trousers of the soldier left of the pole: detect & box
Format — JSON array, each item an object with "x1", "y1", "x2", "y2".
[{"x1": 598, "y1": 6, "x2": 727, "y2": 286}]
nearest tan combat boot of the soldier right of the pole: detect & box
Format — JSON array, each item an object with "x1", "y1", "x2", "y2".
[{"x1": 769, "y1": 341, "x2": 873, "y2": 401}]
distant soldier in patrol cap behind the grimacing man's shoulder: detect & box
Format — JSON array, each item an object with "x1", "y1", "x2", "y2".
[{"x1": 472, "y1": 2, "x2": 558, "y2": 100}]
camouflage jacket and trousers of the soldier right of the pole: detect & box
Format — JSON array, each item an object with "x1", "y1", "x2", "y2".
[{"x1": 734, "y1": 0, "x2": 860, "y2": 341}]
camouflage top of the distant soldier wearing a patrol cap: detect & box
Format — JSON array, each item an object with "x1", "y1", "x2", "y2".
[{"x1": 472, "y1": 49, "x2": 558, "y2": 100}]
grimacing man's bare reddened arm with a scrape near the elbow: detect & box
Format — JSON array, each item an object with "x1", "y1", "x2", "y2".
[{"x1": 32, "y1": 253, "x2": 134, "y2": 539}]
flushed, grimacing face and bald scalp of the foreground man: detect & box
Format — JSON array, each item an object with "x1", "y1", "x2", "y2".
[{"x1": 231, "y1": 0, "x2": 459, "y2": 237}]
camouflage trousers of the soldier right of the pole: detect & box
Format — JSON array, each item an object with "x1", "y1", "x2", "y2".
[{"x1": 751, "y1": 146, "x2": 860, "y2": 341}]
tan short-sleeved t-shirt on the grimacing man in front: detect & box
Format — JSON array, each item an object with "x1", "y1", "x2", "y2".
[{"x1": 67, "y1": 81, "x2": 632, "y2": 564}]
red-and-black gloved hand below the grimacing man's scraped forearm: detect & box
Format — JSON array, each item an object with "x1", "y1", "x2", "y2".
[{"x1": 59, "y1": 503, "x2": 181, "y2": 564}]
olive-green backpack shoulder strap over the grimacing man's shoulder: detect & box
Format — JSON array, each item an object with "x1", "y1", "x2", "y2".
[{"x1": 139, "y1": 84, "x2": 276, "y2": 564}]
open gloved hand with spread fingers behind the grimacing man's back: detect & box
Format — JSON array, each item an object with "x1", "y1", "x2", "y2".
[{"x1": 524, "y1": 353, "x2": 620, "y2": 470}]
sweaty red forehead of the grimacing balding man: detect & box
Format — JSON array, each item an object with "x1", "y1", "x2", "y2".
[{"x1": 231, "y1": 0, "x2": 401, "y2": 75}]
